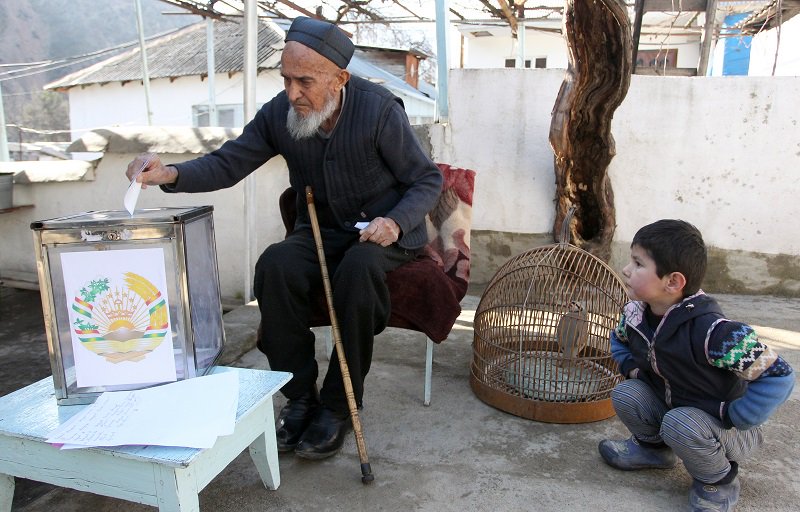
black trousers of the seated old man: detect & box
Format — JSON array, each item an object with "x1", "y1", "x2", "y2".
[{"x1": 254, "y1": 228, "x2": 415, "y2": 413}]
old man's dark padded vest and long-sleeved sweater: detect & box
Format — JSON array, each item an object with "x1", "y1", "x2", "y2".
[{"x1": 163, "y1": 76, "x2": 442, "y2": 249}]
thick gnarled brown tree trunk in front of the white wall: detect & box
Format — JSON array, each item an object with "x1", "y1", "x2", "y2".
[{"x1": 550, "y1": 0, "x2": 632, "y2": 261}]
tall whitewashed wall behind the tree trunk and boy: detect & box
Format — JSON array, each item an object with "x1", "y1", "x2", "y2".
[{"x1": 431, "y1": 69, "x2": 800, "y2": 295}]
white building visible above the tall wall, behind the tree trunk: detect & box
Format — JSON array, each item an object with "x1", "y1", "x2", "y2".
[{"x1": 451, "y1": 0, "x2": 800, "y2": 76}]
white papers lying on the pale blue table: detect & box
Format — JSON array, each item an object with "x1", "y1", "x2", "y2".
[{"x1": 47, "y1": 372, "x2": 239, "y2": 449}]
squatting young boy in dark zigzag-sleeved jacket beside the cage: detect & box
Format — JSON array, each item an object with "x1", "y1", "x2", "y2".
[{"x1": 598, "y1": 220, "x2": 795, "y2": 511}]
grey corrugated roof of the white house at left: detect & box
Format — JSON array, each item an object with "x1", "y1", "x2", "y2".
[{"x1": 45, "y1": 22, "x2": 284, "y2": 90}]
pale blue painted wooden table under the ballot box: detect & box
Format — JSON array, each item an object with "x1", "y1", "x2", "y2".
[{"x1": 0, "y1": 367, "x2": 291, "y2": 512}]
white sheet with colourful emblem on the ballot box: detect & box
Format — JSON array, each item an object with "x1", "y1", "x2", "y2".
[{"x1": 61, "y1": 247, "x2": 177, "y2": 391}]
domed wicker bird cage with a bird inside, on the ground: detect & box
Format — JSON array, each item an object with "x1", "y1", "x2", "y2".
[{"x1": 470, "y1": 212, "x2": 627, "y2": 423}]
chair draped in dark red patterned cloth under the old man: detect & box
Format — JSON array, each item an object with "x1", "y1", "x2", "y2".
[{"x1": 276, "y1": 164, "x2": 475, "y2": 405}]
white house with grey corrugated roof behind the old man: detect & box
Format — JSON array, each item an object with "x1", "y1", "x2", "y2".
[{"x1": 46, "y1": 21, "x2": 435, "y2": 140}]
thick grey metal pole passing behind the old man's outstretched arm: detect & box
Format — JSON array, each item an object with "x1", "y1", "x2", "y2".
[{"x1": 243, "y1": 0, "x2": 258, "y2": 302}]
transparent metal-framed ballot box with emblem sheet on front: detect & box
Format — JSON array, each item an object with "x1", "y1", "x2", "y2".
[{"x1": 31, "y1": 206, "x2": 225, "y2": 405}]
